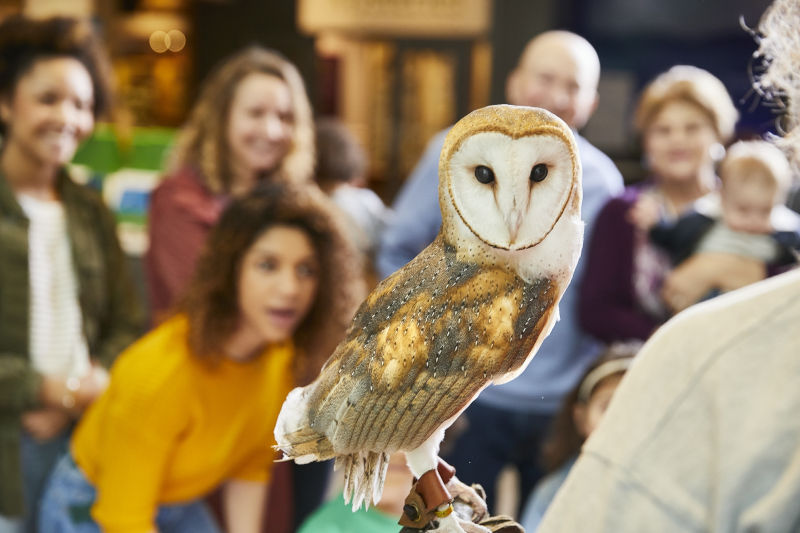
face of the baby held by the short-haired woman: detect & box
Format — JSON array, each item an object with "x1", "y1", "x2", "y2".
[{"x1": 721, "y1": 180, "x2": 777, "y2": 234}]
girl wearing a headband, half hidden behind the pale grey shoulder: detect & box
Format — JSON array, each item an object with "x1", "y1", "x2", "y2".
[{"x1": 520, "y1": 341, "x2": 642, "y2": 533}]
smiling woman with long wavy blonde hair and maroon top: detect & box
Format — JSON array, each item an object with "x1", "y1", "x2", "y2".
[{"x1": 145, "y1": 46, "x2": 314, "y2": 322}]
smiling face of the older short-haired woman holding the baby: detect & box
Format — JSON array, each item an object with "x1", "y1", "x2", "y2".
[{"x1": 644, "y1": 100, "x2": 719, "y2": 183}]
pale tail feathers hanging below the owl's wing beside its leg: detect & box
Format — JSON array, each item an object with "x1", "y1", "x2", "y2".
[{"x1": 334, "y1": 451, "x2": 389, "y2": 511}]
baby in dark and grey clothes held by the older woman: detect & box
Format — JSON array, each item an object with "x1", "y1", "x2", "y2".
[{"x1": 631, "y1": 141, "x2": 800, "y2": 312}]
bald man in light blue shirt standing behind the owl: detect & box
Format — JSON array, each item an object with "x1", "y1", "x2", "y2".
[{"x1": 377, "y1": 31, "x2": 623, "y2": 512}]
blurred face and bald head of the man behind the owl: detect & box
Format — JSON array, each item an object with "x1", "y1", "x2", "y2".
[{"x1": 507, "y1": 38, "x2": 600, "y2": 128}]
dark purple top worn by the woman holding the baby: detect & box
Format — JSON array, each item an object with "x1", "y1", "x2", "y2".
[{"x1": 578, "y1": 187, "x2": 667, "y2": 343}]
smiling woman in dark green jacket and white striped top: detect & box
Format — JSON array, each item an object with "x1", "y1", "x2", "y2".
[{"x1": 0, "y1": 15, "x2": 144, "y2": 533}]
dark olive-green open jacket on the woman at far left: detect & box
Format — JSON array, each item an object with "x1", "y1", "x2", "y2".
[{"x1": 0, "y1": 167, "x2": 144, "y2": 516}]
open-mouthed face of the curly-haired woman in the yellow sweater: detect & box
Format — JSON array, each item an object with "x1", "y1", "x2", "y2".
[{"x1": 231, "y1": 226, "x2": 320, "y2": 353}]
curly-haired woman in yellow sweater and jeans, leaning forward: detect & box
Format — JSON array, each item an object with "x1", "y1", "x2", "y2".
[{"x1": 40, "y1": 184, "x2": 361, "y2": 533}]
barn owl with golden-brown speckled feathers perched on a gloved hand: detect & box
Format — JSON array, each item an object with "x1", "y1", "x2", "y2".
[{"x1": 275, "y1": 105, "x2": 583, "y2": 531}]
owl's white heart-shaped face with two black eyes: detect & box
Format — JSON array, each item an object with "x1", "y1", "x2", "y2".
[{"x1": 443, "y1": 131, "x2": 579, "y2": 250}]
